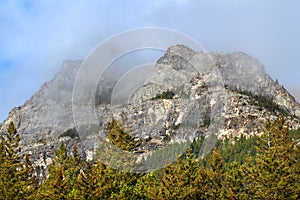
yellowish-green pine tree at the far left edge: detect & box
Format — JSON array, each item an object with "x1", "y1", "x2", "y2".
[{"x1": 0, "y1": 122, "x2": 37, "y2": 199}]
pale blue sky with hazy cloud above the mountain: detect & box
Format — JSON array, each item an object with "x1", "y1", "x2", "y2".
[{"x1": 0, "y1": 0, "x2": 300, "y2": 122}]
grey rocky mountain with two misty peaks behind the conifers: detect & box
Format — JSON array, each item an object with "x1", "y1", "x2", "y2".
[{"x1": 1, "y1": 45, "x2": 300, "y2": 173}]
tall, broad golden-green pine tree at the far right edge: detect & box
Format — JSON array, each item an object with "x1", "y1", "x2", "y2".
[{"x1": 241, "y1": 117, "x2": 300, "y2": 199}]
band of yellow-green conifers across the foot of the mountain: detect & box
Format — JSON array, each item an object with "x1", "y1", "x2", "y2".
[{"x1": 0, "y1": 118, "x2": 300, "y2": 199}]
